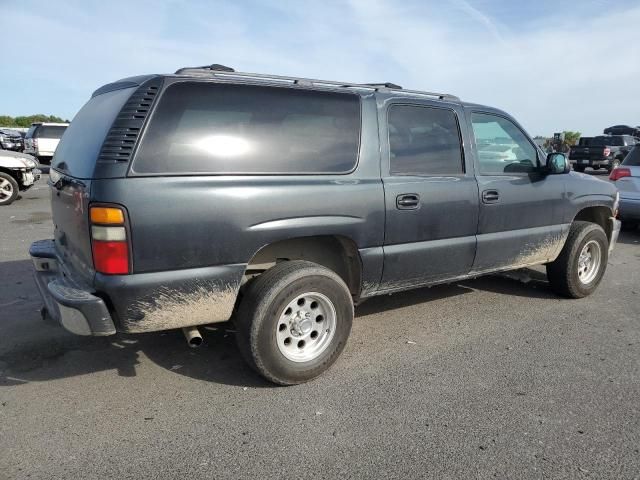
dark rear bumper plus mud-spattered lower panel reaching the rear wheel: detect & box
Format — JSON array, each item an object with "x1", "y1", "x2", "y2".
[{"x1": 29, "y1": 240, "x2": 246, "y2": 335}]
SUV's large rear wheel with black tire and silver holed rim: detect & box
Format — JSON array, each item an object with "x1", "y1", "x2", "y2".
[{"x1": 236, "y1": 260, "x2": 353, "y2": 385}]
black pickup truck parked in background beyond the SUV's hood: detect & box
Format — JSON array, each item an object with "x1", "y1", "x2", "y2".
[{"x1": 569, "y1": 135, "x2": 637, "y2": 172}]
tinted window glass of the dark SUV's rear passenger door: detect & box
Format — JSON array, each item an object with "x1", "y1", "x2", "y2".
[{"x1": 388, "y1": 105, "x2": 463, "y2": 175}]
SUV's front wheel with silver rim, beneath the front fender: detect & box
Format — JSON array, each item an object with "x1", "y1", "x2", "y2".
[{"x1": 547, "y1": 221, "x2": 609, "y2": 298}]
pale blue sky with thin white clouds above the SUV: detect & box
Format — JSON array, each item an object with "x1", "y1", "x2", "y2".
[{"x1": 0, "y1": 0, "x2": 640, "y2": 136}]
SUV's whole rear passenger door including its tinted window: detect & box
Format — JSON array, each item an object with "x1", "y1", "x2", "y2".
[{"x1": 380, "y1": 100, "x2": 478, "y2": 290}]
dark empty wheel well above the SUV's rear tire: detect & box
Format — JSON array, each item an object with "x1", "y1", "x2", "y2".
[{"x1": 245, "y1": 235, "x2": 362, "y2": 297}]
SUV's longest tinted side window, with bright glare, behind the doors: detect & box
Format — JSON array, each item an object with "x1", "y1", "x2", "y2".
[{"x1": 132, "y1": 82, "x2": 360, "y2": 174}]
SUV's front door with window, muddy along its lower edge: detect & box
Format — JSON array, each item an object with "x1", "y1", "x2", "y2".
[{"x1": 467, "y1": 111, "x2": 569, "y2": 273}]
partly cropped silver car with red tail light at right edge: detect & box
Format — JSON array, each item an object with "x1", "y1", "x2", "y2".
[{"x1": 609, "y1": 145, "x2": 640, "y2": 230}]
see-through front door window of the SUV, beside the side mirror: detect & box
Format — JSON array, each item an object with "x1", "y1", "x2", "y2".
[{"x1": 471, "y1": 113, "x2": 538, "y2": 175}]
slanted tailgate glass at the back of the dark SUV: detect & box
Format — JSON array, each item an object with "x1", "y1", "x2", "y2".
[{"x1": 52, "y1": 87, "x2": 136, "y2": 178}]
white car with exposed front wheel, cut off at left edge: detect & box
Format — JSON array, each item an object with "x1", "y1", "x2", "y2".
[{"x1": 0, "y1": 150, "x2": 40, "y2": 206}]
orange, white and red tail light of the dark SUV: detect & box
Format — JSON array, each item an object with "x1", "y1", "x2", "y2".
[{"x1": 89, "y1": 206, "x2": 131, "y2": 275}]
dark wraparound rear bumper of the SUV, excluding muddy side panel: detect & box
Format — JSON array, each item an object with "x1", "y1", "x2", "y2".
[{"x1": 29, "y1": 240, "x2": 116, "y2": 336}]
